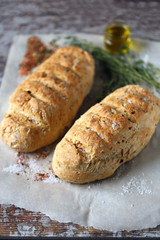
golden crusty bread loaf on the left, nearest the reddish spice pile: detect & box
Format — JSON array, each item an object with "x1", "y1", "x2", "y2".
[{"x1": 0, "y1": 47, "x2": 94, "y2": 152}]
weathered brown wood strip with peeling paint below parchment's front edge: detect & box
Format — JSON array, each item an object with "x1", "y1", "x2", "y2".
[{"x1": 0, "y1": 204, "x2": 160, "y2": 237}]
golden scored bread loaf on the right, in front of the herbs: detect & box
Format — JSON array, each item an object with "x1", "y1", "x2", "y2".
[{"x1": 53, "y1": 85, "x2": 160, "y2": 184}]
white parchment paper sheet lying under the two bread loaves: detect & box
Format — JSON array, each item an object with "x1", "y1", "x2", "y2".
[{"x1": 0, "y1": 34, "x2": 160, "y2": 231}]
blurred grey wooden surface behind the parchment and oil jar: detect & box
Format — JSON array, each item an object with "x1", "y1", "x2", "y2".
[{"x1": 0, "y1": 0, "x2": 160, "y2": 78}]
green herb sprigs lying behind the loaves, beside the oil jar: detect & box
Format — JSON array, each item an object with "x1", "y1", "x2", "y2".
[{"x1": 51, "y1": 36, "x2": 160, "y2": 95}]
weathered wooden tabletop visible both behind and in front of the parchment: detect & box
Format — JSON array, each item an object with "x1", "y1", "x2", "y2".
[{"x1": 0, "y1": 0, "x2": 160, "y2": 239}]
